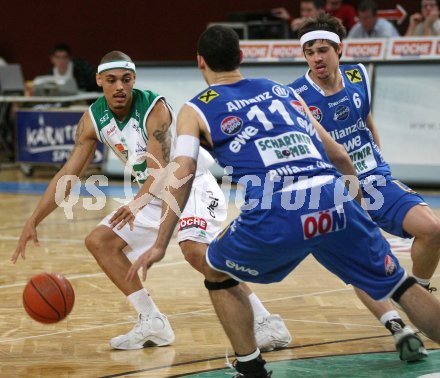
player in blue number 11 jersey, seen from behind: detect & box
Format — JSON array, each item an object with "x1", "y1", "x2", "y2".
[{"x1": 126, "y1": 26, "x2": 440, "y2": 378}]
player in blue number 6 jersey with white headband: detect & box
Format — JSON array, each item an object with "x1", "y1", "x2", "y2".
[{"x1": 290, "y1": 14, "x2": 440, "y2": 361}]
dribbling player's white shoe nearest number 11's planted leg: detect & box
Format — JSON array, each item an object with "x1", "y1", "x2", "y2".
[{"x1": 254, "y1": 315, "x2": 292, "y2": 352}]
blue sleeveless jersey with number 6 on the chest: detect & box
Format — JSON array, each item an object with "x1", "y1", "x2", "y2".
[{"x1": 289, "y1": 64, "x2": 391, "y2": 180}]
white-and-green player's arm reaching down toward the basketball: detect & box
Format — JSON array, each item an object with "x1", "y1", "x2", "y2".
[{"x1": 11, "y1": 112, "x2": 97, "y2": 264}]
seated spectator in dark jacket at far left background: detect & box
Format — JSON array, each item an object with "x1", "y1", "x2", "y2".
[{"x1": 50, "y1": 43, "x2": 101, "y2": 92}]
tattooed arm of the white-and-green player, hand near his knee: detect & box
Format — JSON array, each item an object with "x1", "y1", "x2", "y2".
[{"x1": 109, "y1": 100, "x2": 172, "y2": 230}]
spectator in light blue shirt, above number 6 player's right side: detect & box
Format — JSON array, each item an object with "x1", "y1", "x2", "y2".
[{"x1": 348, "y1": 0, "x2": 400, "y2": 38}]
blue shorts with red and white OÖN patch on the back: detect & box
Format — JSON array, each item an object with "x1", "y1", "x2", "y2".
[{"x1": 206, "y1": 176, "x2": 406, "y2": 299}]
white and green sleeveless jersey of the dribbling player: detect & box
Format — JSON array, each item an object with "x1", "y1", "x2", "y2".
[{"x1": 89, "y1": 89, "x2": 170, "y2": 183}]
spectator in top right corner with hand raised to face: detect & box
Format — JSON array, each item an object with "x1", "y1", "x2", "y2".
[{"x1": 405, "y1": 0, "x2": 440, "y2": 37}]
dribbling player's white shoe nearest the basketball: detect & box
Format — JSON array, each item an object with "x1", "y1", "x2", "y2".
[{"x1": 110, "y1": 313, "x2": 175, "y2": 349}]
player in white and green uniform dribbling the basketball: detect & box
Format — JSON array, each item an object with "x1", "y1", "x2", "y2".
[{"x1": 12, "y1": 51, "x2": 291, "y2": 351}]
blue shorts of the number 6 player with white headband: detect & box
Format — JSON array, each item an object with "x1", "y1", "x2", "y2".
[{"x1": 362, "y1": 175, "x2": 426, "y2": 238}]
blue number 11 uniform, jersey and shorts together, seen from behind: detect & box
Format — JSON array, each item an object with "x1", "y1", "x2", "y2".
[{"x1": 196, "y1": 79, "x2": 404, "y2": 292}]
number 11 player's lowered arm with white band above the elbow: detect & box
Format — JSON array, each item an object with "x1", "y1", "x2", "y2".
[{"x1": 126, "y1": 105, "x2": 200, "y2": 281}]
